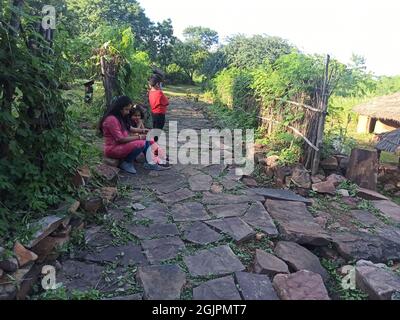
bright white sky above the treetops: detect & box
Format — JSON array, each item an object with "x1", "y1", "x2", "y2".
[{"x1": 139, "y1": 0, "x2": 400, "y2": 75}]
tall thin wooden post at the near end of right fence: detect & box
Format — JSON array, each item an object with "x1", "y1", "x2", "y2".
[{"x1": 311, "y1": 55, "x2": 330, "y2": 175}]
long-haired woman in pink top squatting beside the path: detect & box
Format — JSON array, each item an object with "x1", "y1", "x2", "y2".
[{"x1": 99, "y1": 96, "x2": 165, "y2": 174}]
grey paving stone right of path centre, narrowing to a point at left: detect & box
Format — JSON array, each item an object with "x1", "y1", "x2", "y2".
[{"x1": 206, "y1": 218, "x2": 256, "y2": 242}]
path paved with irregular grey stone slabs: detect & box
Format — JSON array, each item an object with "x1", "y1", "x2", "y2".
[{"x1": 58, "y1": 99, "x2": 400, "y2": 300}]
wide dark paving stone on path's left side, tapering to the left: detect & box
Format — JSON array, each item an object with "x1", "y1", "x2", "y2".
[{"x1": 83, "y1": 245, "x2": 148, "y2": 267}]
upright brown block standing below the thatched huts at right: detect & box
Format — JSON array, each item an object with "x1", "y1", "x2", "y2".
[{"x1": 346, "y1": 149, "x2": 379, "y2": 190}]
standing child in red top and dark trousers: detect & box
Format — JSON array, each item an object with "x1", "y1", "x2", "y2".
[{"x1": 149, "y1": 74, "x2": 169, "y2": 130}]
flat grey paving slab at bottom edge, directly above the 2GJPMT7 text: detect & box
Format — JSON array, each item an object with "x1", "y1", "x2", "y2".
[{"x1": 193, "y1": 276, "x2": 242, "y2": 300}]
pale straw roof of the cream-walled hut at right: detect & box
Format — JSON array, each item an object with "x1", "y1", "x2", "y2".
[{"x1": 354, "y1": 92, "x2": 400, "y2": 122}]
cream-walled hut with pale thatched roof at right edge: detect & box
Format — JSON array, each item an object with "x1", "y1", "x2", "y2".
[{"x1": 354, "y1": 92, "x2": 400, "y2": 133}]
